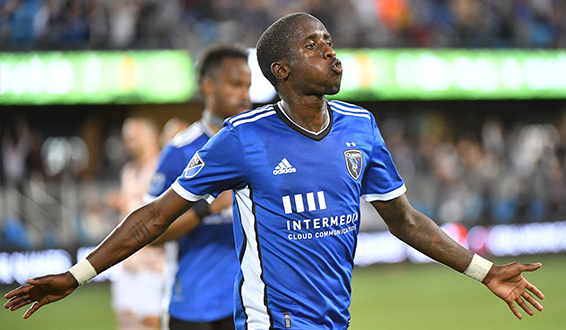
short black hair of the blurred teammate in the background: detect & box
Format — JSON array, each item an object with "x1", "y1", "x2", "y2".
[{"x1": 197, "y1": 45, "x2": 248, "y2": 86}]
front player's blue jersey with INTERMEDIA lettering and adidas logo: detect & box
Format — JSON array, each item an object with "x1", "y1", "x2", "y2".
[{"x1": 172, "y1": 101, "x2": 406, "y2": 330}]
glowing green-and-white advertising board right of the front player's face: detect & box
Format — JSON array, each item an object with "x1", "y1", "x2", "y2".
[{"x1": 335, "y1": 49, "x2": 566, "y2": 101}]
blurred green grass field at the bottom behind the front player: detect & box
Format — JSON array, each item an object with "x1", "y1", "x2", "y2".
[{"x1": 0, "y1": 255, "x2": 566, "y2": 330}]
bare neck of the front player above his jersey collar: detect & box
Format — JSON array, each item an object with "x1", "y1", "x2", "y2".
[{"x1": 281, "y1": 96, "x2": 328, "y2": 132}]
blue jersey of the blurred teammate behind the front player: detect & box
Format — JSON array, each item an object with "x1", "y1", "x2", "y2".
[{"x1": 147, "y1": 120, "x2": 240, "y2": 322}]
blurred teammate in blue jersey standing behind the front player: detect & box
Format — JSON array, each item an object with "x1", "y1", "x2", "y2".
[{"x1": 146, "y1": 45, "x2": 251, "y2": 330}]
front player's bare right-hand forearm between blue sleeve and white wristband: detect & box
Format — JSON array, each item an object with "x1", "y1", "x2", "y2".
[{"x1": 372, "y1": 196, "x2": 473, "y2": 272}]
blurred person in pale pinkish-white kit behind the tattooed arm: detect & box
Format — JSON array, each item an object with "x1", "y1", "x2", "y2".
[{"x1": 107, "y1": 117, "x2": 165, "y2": 330}]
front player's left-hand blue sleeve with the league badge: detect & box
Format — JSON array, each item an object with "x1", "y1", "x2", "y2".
[{"x1": 172, "y1": 125, "x2": 246, "y2": 202}]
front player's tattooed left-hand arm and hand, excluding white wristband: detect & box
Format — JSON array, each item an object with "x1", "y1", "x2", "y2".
[{"x1": 4, "y1": 189, "x2": 193, "y2": 318}]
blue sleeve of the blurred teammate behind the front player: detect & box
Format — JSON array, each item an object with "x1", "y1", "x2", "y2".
[{"x1": 148, "y1": 145, "x2": 188, "y2": 199}]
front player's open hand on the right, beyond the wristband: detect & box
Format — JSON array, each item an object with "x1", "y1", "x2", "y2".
[{"x1": 483, "y1": 262, "x2": 544, "y2": 319}]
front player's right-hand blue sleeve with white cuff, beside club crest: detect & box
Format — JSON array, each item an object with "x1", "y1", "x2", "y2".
[{"x1": 362, "y1": 120, "x2": 407, "y2": 202}]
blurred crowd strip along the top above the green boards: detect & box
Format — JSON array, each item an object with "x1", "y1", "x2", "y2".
[{"x1": 0, "y1": 0, "x2": 566, "y2": 53}]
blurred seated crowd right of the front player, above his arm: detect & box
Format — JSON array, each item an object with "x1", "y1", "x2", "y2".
[{"x1": 378, "y1": 109, "x2": 566, "y2": 229}]
